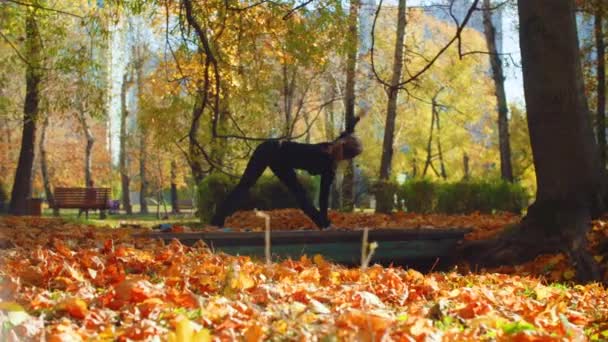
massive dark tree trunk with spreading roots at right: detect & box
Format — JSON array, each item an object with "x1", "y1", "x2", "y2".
[{"x1": 468, "y1": 0, "x2": 605, "y2": 281}]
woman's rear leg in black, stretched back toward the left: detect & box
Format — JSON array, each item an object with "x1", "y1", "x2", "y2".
[{"x1": 211, "y1": 141, "x2": 279, "y2": 227}]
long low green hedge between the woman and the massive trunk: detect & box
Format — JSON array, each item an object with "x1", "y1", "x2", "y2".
[{"x1": 401, "y1": 180, "x2": 530, "y2": 214}]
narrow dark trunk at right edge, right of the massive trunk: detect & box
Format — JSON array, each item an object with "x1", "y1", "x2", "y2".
[{"x1": 595, "y1": 0, "x2": 606, "y2": 170}]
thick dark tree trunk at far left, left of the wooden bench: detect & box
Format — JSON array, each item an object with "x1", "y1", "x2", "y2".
[{"x1": 9, "y1": 10, "x2": 42, "y2": 215}]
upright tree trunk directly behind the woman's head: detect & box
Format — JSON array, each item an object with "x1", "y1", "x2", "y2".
[{"x1": 342, "y1": 0, "x2": 361, "y2": 211}]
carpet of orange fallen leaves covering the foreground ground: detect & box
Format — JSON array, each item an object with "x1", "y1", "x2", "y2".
[{"x1": 0, "y1": 217, "x2": 608, "y2": 341}]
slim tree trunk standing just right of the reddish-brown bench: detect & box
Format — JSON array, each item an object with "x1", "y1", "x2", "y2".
[{"x1": 119, "y1": 71, "x2": 133, "y2": 215}]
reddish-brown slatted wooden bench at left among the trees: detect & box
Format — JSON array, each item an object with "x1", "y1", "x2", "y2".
[{"x1": 53, "y1": 188, "x2": 110, "y2": 219}]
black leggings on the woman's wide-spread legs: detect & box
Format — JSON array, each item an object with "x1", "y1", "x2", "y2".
[{"x1": 211, "y1": 141, "x2": 329, "y2": 228}]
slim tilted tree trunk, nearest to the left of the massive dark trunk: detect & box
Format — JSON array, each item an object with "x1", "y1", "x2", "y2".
[{"x1": 483, "y1": 0, "x2": 513, "y2": 182}]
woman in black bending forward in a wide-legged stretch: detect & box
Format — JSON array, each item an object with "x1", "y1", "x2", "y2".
[{"x1": 211, "y1": 133, "x2": 363, "y2": 229}]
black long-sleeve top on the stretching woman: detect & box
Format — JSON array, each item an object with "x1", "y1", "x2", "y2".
[{"x1": 281, "y1": 141, "x2": 335, "y2": 218}]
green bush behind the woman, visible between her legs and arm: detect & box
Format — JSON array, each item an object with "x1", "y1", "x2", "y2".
[{"x1": 197, "y1": 173, "x2": 319, "y2": 222}]
